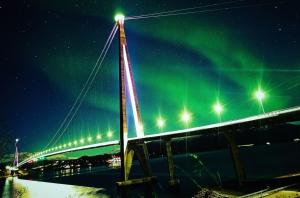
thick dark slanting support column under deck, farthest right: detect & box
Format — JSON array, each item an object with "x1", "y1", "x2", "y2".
[{"x1": 224, "y1": 132, "x2": 246, "y2": 186}]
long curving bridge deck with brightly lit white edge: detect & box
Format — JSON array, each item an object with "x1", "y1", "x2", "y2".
[{"x1": 19, "y1": 106, "x2": 300, "y2": 167}]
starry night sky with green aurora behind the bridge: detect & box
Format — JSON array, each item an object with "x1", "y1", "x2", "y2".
[{"x1": 0, "y1": 0, "x2": 300, "y2": 151}]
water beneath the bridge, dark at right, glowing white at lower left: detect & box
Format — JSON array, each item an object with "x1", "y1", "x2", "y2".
[{"x1": 0, "y1": 143, "x2": 300, "y2": 197}]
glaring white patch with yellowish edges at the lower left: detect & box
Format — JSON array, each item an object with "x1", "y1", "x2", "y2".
[{"x1": 2, "y1": 177, "x2": 109, "y2": 198}]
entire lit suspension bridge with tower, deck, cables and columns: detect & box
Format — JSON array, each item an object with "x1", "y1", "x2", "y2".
[{"x1": 15, "y1": 2, "x2": 300, "y2": 195}]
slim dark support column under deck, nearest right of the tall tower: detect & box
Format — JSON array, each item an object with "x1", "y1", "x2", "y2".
[{"x1": 164, "y1": 139, "x2": 180, "y2": 191}]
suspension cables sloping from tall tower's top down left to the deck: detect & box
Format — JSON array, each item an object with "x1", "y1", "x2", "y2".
[{"x1": 44, "y1": 24, "x2": 118, "y2": 149}]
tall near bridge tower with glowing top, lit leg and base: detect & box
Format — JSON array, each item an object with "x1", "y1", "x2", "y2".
[{"x1": 115, "y1": 15, "x2": 155, "y2": 193}]
